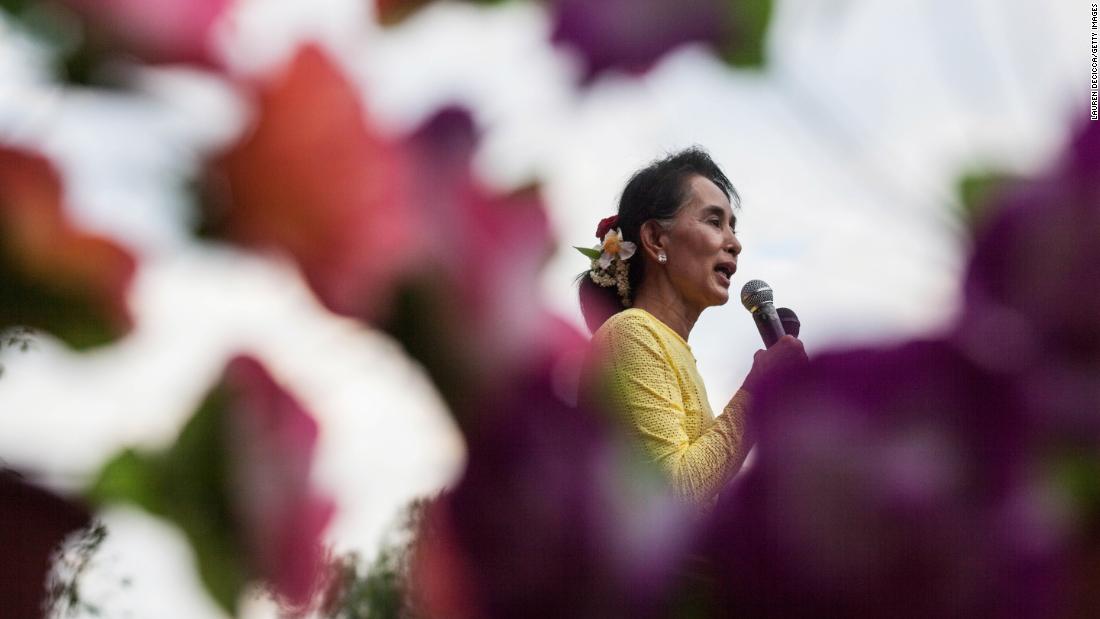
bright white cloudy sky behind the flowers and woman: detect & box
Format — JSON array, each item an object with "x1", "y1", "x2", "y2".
[{"x1": 0, "y1": 0, "x2": 1088, "y2": 618}]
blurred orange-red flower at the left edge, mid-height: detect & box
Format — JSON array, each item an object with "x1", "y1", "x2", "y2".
[{"x1": 0, "y1": 147, "x2": 136, "y2": 346}]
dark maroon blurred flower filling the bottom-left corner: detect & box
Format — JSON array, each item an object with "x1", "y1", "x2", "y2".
[{"x1": 0, "y1": 469, "x2": 90, "y2": 619}]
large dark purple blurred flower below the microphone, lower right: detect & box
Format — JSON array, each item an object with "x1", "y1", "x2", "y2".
[{"x1": 704, "y1": 342, "x2": 1066, "y2": 618}]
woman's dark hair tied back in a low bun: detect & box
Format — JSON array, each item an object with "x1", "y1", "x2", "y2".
[{"x1": 579, "y1": 146, "x2": 740, "y2": 333}]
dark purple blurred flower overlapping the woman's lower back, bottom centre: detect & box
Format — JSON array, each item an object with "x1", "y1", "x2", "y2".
[{"x1": 414, "y1": 330, "x2": 694, "y2": 618}]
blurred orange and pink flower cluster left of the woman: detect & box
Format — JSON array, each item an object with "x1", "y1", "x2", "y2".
[{"x1": 204, "y1": 46, "x2": 552, "y2": 415}]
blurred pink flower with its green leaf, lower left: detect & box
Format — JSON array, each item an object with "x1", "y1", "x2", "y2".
[{"x1": 90, "y1": 356, "x2": 334, "y2": 612}]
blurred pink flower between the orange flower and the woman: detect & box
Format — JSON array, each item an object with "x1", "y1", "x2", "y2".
[{"x1": 388, "y1": 109, "x2": 553, "y2": 411}]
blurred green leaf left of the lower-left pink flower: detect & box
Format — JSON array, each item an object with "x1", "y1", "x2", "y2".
[{"x1": 90, "y1": 389, "x2": 248, "y2": 614}]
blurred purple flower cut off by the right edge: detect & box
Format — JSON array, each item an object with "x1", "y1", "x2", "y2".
[{"x1": 955, "y1": 122, "x2": 1100, "y2": 435}]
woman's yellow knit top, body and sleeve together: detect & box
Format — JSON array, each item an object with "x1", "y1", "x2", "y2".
[{"x1": 592, "y1": 308, "x2": 749, "y2": 505}]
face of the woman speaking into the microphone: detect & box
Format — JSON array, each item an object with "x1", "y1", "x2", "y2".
[{"x1": 664, "y1": 175, "x2": 741, "y2": 311}]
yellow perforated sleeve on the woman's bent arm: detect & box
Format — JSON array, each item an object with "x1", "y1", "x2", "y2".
[{"x1": 597, "y1": 320, "x2": 748, "y2": 504}]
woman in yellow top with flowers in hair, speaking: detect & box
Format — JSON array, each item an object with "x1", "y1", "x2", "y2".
[{"x1": 580, "y1": 148, "x2": 805, "y2": 506}]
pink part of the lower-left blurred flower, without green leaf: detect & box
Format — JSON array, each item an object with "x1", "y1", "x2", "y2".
[{"x1": 218, "y1": 356, "x2": 334, "y2": 605}]
